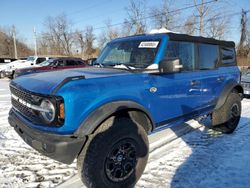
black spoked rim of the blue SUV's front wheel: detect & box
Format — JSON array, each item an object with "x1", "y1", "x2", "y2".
[{"x1": 105, "y1": 139, "x2": 137, "y2": 182}]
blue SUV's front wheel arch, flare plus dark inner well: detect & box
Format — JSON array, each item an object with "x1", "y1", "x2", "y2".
[{"x1": 74, "y1": 101, "x2": 154, "y2": 137}]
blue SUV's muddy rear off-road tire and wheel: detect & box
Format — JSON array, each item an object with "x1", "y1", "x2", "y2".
[{"x1": 212, "y1": 92, "x2": 241, "y2": 134}]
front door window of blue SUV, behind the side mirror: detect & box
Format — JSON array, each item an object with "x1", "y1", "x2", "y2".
[{"x1": 165, "y1": 41, "x2": 195, "y2": 71}]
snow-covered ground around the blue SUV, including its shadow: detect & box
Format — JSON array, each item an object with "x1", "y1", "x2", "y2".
[{"x1": 0, "y1": 77, "x2": 250, "y2": 188}]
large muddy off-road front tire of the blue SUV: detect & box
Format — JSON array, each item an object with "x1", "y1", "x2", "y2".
[{"x1": 77, "y1": 116, "x2": 149, "y2": 188}]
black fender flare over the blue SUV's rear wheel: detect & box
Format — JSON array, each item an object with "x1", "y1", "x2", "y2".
[{"x1": 215, "y1": 81, "x2": 243, "y2": 110}]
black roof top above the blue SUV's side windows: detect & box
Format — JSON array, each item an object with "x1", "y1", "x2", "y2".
[{"x1": 166, "y1": 33, "x2": 235, "y2": 48}]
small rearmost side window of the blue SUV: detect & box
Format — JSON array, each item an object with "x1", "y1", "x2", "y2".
[{"x1": 220, "y1": 47, "x2": 236, "y2": 65}]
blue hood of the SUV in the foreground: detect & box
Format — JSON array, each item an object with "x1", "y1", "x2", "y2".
[{"x1": 11, "y1": 67, "x2": 132, "y2": 94}]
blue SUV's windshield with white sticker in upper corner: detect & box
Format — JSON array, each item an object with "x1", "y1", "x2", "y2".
[{"x1": 96, "y1": 40, "x2": 160, "y2": 69}]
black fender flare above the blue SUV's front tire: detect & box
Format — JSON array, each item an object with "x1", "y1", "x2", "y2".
[{"x1": 74, "y1": 101, "x2": 154, "y2": 137}]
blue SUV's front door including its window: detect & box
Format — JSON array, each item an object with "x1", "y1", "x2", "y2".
[{"x1": 150, "y1": 41, "x2": 201, "y2": 126}]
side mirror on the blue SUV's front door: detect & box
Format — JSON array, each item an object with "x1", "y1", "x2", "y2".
[{"x1": 159, "y1": 58, "x2": 183, "y2": 73}]
